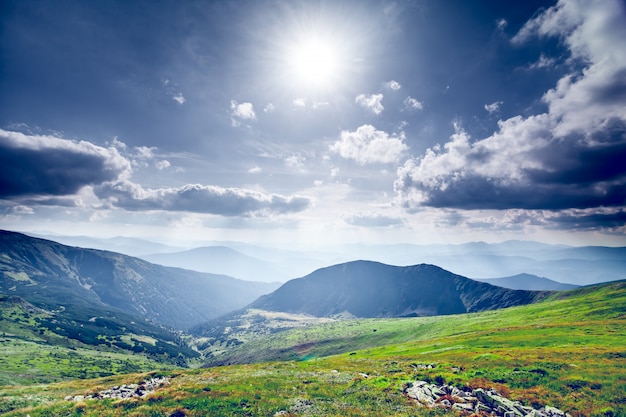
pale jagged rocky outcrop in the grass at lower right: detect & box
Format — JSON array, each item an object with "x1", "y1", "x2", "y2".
[{"x1": 404, "y1": 381, "x2": 571, "y2": 417}]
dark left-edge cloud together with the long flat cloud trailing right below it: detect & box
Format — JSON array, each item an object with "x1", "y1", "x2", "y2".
[{"x1": 0, "y1": 129, "x2": 311, "y2": 216}]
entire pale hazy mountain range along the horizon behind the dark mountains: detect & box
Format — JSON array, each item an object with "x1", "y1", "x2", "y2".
[{"x1": 39, "y1": 235, "x2": 626, "y2": 289}]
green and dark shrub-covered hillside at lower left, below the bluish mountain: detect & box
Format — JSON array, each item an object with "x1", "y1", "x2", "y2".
[{"x1": 0, "y1": 295, "x2": 180, "y2": 385}]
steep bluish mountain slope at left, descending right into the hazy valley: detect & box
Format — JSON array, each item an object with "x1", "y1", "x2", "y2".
[{"x1": 0, "y1": 231, "x2": 276, "y2": 330}]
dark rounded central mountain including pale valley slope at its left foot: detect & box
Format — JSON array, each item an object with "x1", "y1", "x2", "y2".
[{"x1": 189, "y1": 261, "x2": 555, "y2": 365}]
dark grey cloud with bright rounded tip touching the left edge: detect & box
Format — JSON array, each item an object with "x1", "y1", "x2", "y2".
[{"x1": 0, "y1": 129, "x2": 131, "y2": 199}]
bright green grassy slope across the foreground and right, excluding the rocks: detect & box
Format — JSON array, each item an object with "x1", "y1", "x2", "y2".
[{"x1": 0, "y1": 282, "x2": 626, "y2": 417}]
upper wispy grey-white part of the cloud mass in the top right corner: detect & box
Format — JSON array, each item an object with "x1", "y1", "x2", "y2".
[{"x1": 512, "y1": 0, "x2": 626, "y2": 135}]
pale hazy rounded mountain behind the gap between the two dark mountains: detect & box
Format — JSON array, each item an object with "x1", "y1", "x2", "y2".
[{"x1": 141, "y1": 246, "x2": 287, "y2": 282}]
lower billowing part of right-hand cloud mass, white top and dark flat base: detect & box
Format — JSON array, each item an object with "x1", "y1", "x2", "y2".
[{"x1": 395, "y1": 116, "x2": 626, "y2": 210}]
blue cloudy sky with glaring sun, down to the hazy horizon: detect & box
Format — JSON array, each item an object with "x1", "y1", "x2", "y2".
[{"x1": 0, "y1": 0, "x2": 626, "y2": 247}]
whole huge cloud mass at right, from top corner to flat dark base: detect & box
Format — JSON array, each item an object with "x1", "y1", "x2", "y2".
[{"x1": 395, "y1": 1, "x2": 626, "y2": 221}]
